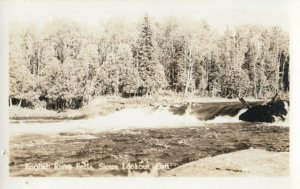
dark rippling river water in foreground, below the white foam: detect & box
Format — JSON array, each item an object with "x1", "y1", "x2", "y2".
[{"x1": 9, "y1": 123, "x2": 289, "y2": 176}]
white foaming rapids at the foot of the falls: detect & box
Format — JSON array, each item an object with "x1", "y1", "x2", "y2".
[{"x1": 10, "y1": 107, "x2": 288, "y2": 135}]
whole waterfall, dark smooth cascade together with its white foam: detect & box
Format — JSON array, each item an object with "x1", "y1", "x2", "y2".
[{"x1": 10, "y1": 102, "x2": 289, "y2": 135}]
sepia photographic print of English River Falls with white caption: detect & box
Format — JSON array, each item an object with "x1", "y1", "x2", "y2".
[{"x1": 6, "y1": 0, "x2": 290, "y2": 177}]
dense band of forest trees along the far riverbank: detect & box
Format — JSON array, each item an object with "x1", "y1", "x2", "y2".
[{"x1": 9, "y1": 15, "x2": 289, "y2": 110}]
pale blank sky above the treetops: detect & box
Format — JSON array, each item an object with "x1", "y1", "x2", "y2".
[{"x1": 4, "y1": 0, "x2": 290, "y2": 31}]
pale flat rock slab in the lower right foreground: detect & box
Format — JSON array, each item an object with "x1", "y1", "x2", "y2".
[{"x1": 161, "y1": 149, "x2": 289, "y2": 176}]
